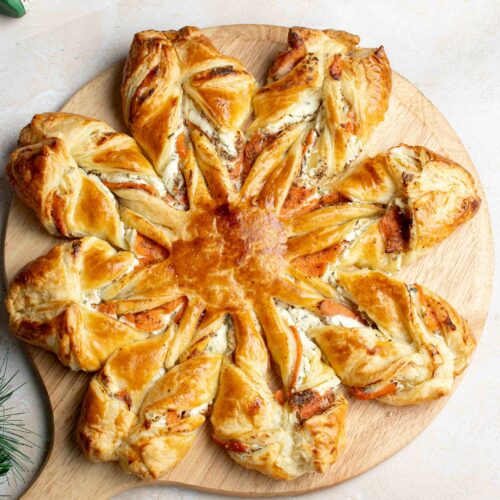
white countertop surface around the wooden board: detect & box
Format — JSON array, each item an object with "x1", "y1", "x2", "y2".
[{"x1": 0, "y1": 0, "x2": 500, "y2": 500}]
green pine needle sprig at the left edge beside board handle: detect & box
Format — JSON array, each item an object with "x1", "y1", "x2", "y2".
[{"x1": 0, "y1": 351, "x2": 36, "y2": 484}]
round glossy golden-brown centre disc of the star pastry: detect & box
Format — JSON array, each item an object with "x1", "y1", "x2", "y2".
[{"x1": 170, "y1": 203, "x2": 287, "y2": 311}]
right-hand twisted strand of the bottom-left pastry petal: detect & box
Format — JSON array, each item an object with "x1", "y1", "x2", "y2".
[{"x1": 118, "y1": 310, "x2": 224, "y2": 478}]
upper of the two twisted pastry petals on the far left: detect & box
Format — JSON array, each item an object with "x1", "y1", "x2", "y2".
[{"x1": 7, "y1": 113, "x2": 184, "y2": 256}]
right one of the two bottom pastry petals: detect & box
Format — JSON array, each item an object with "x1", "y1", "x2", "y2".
[{"x1": 211, "y1": 310, "x2": 347, "y2": 479}]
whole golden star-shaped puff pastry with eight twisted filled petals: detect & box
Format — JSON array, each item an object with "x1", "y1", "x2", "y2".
[{"x1": 7, "y1": 28, "x2": 480, "y2": 479}]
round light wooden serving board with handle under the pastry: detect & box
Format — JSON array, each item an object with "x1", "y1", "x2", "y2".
[{"x1": 5, "y1": 25, "x2": 493, "y2": 499}]
